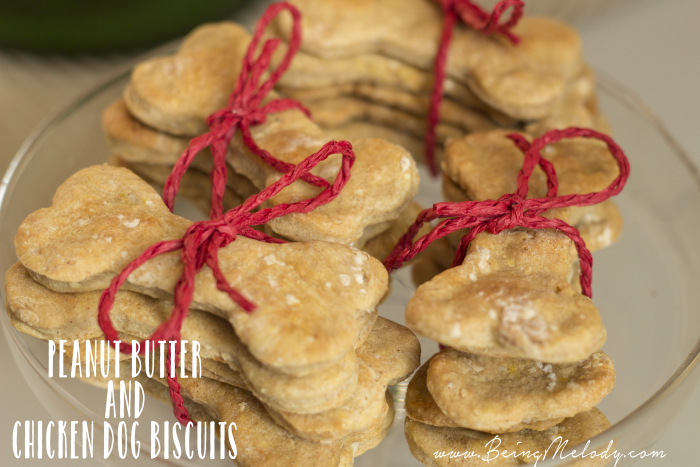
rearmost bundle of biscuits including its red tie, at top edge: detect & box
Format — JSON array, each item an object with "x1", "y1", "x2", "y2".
[{"x1": 274, "y1": 0, "x2": 606, "y2": 174}]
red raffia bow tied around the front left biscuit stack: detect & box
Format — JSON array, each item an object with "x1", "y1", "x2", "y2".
[{"x1": 97, "y1": 141, "x2": 355, "y2": 424}]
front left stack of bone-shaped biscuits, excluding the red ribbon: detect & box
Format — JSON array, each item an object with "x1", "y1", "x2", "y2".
[{"x1": 6, "y1": 165, "x2": 420, "y2": 465}]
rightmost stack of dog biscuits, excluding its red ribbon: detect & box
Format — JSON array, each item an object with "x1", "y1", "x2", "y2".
[{"x1": 405, "y1": 130, "x2": 621, "y2": 466}]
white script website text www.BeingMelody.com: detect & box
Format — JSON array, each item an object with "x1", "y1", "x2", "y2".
[{"x1": 433, "y1": 435, "x2": 666, "y2": 467}]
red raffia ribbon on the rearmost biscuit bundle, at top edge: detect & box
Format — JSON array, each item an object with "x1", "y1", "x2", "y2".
[{"x1": 425, "y1": 0, "x2": 525, "y2": 175}]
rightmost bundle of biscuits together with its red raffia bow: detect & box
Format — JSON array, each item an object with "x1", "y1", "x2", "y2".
[{"x1": 386, "y1": 129, "x2": 629, "y2": 466}]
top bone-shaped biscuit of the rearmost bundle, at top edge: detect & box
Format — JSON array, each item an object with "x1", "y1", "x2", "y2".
[{"x1": 276, "y1": 0, "x2": 581, "y2": 119}]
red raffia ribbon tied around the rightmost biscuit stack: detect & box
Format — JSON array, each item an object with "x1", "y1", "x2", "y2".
[{"x1": 384, "y1": 128, "x2": 630, "y2": 298}]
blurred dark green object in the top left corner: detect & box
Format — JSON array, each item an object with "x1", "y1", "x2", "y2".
[{"x1": 0, "y1": 0, "x2": 249, "y2": 54}]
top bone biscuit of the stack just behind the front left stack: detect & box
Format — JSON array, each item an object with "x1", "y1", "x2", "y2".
[{"x1": 124, "y1": 23, "x2": 419, "y2": 247}]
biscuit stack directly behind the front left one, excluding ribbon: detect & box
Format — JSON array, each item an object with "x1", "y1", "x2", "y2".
[{"x1": 103, "y1": 22, "x2": 420, "y2": 264}]
